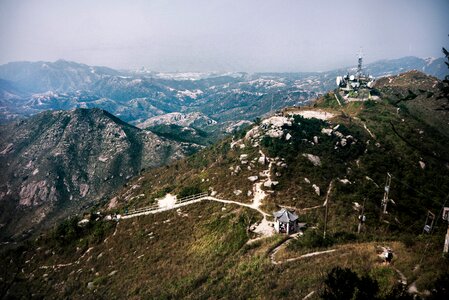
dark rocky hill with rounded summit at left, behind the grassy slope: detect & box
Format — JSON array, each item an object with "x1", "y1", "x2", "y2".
[{"x1": 0, "y1": 109, "x2": 194, "y2": 239}]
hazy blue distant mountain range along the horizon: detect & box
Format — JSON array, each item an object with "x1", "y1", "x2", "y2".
[{"x1": 0, "y1": 57, "x2": 447, "y2": 126}]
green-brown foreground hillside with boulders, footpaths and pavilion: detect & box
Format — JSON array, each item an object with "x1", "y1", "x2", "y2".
[{"x1": 0, "y1": 72, "x2": 449, "y2": 299}]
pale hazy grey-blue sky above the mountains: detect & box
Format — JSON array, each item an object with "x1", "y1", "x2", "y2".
[{"x1": 0, "y1": 0, "x2": 449, "y2": 71}]
